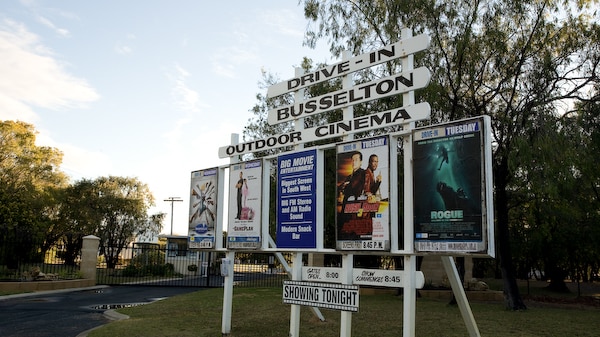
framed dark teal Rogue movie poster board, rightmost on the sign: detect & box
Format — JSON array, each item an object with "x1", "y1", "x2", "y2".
[{"x1": 413, "y1": 116, "x2": 494, "y2": 256}]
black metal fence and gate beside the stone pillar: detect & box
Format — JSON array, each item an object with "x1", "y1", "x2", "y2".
[{"x1": 0, "y1": 242, "x2": 289, "y2": 287}]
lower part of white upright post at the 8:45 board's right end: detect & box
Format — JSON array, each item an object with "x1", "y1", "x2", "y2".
[{"x1": 402, "y1": 255, "x2": 417, "y2": 337}]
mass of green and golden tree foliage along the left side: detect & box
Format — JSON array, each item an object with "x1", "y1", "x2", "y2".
[{"x1": 0, "y1": 121, "x2": 164, "y2": 269}]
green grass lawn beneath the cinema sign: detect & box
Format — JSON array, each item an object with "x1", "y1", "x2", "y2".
[{"x1": 89, "y1": 288, "x2": 600, "y2": 337}]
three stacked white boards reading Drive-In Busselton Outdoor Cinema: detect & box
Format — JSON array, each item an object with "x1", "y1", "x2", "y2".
[{"x1": 219, "y1": 34, "x2": 431, "y2": 158}]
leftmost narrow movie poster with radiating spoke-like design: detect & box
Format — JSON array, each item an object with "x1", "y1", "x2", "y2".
[{"x1": 188, "y1": 168, "x2": 218, "y2": 249}]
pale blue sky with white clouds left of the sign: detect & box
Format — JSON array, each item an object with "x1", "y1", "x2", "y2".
[{"x1": 0, "y1": 0, "x2": 335, "y2": 235}]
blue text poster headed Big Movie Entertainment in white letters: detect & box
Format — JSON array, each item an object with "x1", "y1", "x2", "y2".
[{"x1": 277, "y1": 150, "x2": 317, "y2": 249}]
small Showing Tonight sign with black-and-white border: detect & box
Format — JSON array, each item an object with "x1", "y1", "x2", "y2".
[{"x1": 283, "y1": 281, "x2": 359, "y2": 312}]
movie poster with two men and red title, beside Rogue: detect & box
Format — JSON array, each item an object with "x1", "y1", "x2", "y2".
[{"x1": 336, "y1": 137, "x2": 390, "y2": 250}]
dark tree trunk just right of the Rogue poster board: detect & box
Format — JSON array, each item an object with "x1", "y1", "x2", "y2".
[{"x1": 494, "y1": 159, "x2": 527, "y2": 310}]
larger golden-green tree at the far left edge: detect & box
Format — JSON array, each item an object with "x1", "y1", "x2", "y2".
[{"x1": 0, "y1": 121, "x2": 67, "y2": 268}]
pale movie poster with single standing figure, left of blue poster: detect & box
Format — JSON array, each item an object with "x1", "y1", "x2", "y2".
[{"x1": 227, "y1": 160, "x2": 262, "y2": 249}]
